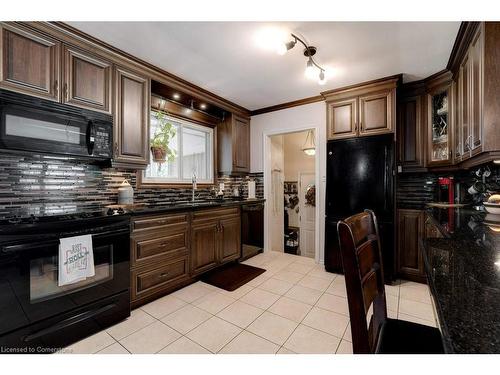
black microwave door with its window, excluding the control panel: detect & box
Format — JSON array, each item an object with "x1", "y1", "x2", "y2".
[{"x1": 0, "y1": 105, "x2": 95, "y2": 157}]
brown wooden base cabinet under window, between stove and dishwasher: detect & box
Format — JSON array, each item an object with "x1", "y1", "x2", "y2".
[{"x1": 130, "y1": 207, "x2": 241, "y2": 308}]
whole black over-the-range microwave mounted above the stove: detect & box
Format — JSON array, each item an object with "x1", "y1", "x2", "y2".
[{"x1": 0, "y1": 90, "x2": 113, "y2": 161}]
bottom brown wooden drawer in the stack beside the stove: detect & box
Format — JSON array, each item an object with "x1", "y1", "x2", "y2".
[{"x1": 132, "y1": 256, "x2": 189, "y2": 300}]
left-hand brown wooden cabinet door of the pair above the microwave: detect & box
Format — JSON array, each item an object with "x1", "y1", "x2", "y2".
[{"x1": 0, "y1": 25, "x2": 60, "y2": 101}]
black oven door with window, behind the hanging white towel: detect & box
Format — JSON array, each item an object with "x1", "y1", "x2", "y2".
[{"x1": 0, "y1": 229, "x2": 130, "y2": 335}]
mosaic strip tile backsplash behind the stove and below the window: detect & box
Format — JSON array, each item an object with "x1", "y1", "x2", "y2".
[{"x1": 0, "y1": 153, "x2": 264, "y2": 218}]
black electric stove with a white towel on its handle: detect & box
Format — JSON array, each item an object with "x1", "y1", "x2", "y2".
[{"x1": 0, "y1": 210, "x2": 130, "y2": 353}]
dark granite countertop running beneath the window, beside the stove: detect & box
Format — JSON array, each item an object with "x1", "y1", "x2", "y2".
[{"x1": 126, "y1": 199, "x2": 266, "y2": 215}]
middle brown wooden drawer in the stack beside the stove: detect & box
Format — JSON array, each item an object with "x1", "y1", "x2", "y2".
[{"x1": 132, "y1": 228, "x2": 189, "y2": 266}]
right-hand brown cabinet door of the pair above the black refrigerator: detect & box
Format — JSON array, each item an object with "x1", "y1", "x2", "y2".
[{"x1": 359, "y1": 90, "x2": 393, "y2": 136}]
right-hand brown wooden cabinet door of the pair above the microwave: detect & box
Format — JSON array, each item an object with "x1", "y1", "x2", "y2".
[{"x1": 63, "y1": 46, "x2": 111, "y2": 113}]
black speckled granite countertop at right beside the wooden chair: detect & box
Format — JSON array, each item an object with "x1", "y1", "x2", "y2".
[{"x1": 423, "y1": 208, "x2": 500, "y2": 353}]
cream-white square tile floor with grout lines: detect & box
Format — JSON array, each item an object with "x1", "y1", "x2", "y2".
[{"x1": 63, "y1": 252, "x2": 435, "y2": 354}]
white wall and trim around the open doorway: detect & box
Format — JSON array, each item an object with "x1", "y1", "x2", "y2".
[{"x1": 250, "y1": 102, "x2": 326, "y2": 263}]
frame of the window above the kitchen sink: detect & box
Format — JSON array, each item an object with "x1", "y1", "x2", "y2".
[{"x1": 137, "y1": 108, "x2": 217, "y2": 188}]
